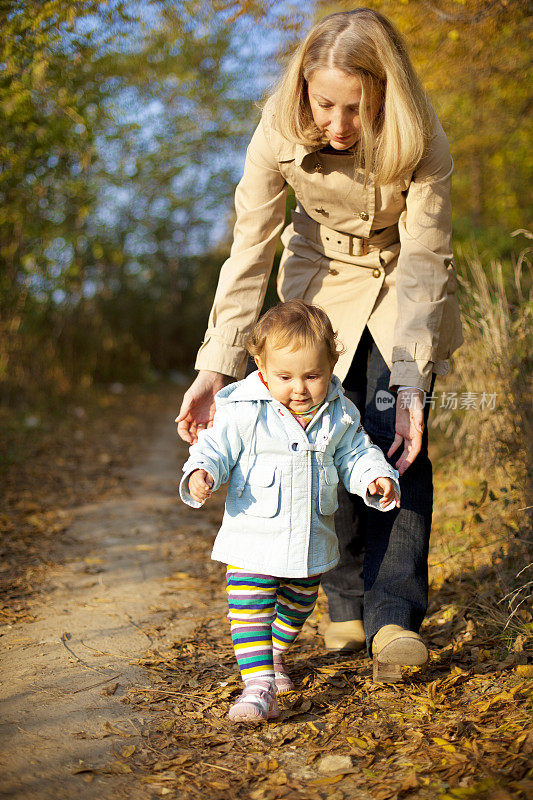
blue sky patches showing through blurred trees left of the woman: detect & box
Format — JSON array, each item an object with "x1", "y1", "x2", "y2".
[{"x1": 42, "y1": 0, "x2": 314, "y2": 302}]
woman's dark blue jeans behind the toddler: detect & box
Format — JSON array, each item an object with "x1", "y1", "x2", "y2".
[{"x1": 322, "y1": 328, "x2": 433, "y2": 646}]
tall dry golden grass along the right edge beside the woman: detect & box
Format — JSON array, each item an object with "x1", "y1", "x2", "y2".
[{"x1": 430, "y1": 231, "x2": 533, "y2": 655}]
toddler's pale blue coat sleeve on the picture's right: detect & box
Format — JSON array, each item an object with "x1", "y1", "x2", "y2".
[{"x1": 334, "y1": 400, "x2": 400, "y2": 511}]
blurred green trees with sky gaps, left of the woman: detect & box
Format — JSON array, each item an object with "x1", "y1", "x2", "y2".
[{"x1": 0, "y1": 0, "x2": 266, "y2": 401}]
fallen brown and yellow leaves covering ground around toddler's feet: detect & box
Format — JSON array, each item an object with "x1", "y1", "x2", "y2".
[{"x1": 114, "y1": 524, "x2": 533, "y2": 800}]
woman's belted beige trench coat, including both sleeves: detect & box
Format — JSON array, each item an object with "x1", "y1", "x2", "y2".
[{"x1": 196, "y1": 101, "x2": 463, "y2": 390}]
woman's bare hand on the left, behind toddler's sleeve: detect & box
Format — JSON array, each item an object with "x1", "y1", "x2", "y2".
[{"x1": 176, "y1": 369, "x2": 233, "y2": 444}]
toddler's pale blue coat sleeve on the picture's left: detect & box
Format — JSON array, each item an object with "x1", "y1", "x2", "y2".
[{"x1": 179, "y1": 411, "x2": 243, "y2": 508}]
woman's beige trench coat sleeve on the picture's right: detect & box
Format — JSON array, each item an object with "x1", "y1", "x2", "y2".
[{"x1": 390, "y1": 112, "x2": 454, "y2": 391}]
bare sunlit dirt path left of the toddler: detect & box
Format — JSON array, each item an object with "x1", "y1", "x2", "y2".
[{"x1": 0, "y1": 410, "x2": 208, "y2": 800}]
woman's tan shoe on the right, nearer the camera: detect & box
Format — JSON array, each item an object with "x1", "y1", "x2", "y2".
[{"x1": 372, "y1": 625, "x2": 428, "y2": 683}]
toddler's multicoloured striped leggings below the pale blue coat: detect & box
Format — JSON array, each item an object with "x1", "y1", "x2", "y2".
[{"x1": 226, "y1": 566, "x2": 321, "y2": 682}]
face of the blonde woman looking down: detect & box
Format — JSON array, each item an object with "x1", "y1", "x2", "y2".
[{"x1": 308, "y1": 67, "x2": 363, "y2": 150}]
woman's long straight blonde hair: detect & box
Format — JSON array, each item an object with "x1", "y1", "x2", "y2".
[{"x1": 273, "y1": 8, "x2": 432, "y2": 185}]
